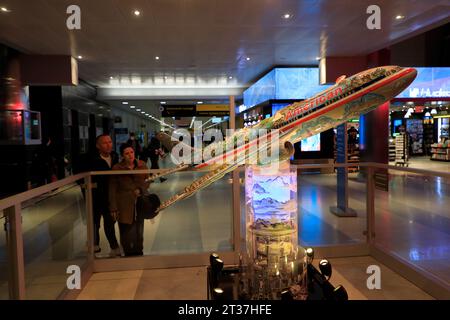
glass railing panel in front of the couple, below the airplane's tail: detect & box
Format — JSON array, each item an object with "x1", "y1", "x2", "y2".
[{"x1": 96, "y1": 171, "x2": 234, "y2": 258}]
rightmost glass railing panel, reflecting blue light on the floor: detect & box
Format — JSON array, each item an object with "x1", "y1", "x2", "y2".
[{"x1": 375, "y1": 169, "x2": 450, "y2": 283}]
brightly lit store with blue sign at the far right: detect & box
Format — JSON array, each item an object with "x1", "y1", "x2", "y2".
[{"x1": 389, "y1": 68, "x2": 450, "y2": 166}]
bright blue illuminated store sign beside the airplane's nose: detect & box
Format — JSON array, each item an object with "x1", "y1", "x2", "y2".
[{"x1": 397, "y1": 68, "x2": 450, "y2": 98}]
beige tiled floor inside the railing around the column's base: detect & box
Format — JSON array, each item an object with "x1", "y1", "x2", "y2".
[{"x1": 78, "y1": 257, "x2": 433, "y2": 300}]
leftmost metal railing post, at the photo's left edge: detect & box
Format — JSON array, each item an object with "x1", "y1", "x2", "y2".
[{"x1": 4, "y1": 203, "x2": 25, "y2": 300}]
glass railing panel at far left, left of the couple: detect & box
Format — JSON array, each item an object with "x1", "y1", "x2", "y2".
[{"x1": 22, "y1": 184, "x2": 88, "y2": 300}]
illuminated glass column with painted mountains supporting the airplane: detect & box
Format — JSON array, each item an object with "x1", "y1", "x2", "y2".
[{"x1": 245, "y1": 161, "x2": 307, "y2": 300}]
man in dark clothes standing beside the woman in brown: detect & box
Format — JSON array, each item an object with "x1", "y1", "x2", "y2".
[{"x1": 89, "y1": 134, "x2": 120, "y2": 256}]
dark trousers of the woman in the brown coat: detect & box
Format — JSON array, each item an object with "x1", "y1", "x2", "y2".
[{"x1": 119, "y1": 219, "x2": 144, "y2": 256}]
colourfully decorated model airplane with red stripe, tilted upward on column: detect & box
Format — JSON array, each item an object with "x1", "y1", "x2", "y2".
[{"x1": 157, "y1": 66, "x2": 417, "y2": 212}]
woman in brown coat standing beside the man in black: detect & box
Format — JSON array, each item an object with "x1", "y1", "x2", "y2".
[{"x1": 109, "y1": 144, "x2": 149, "y2": 256}]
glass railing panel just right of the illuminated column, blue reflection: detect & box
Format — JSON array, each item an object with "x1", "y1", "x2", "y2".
[{"x1": 297, "y1": 168, "x2": 366, "y2": 246}]
